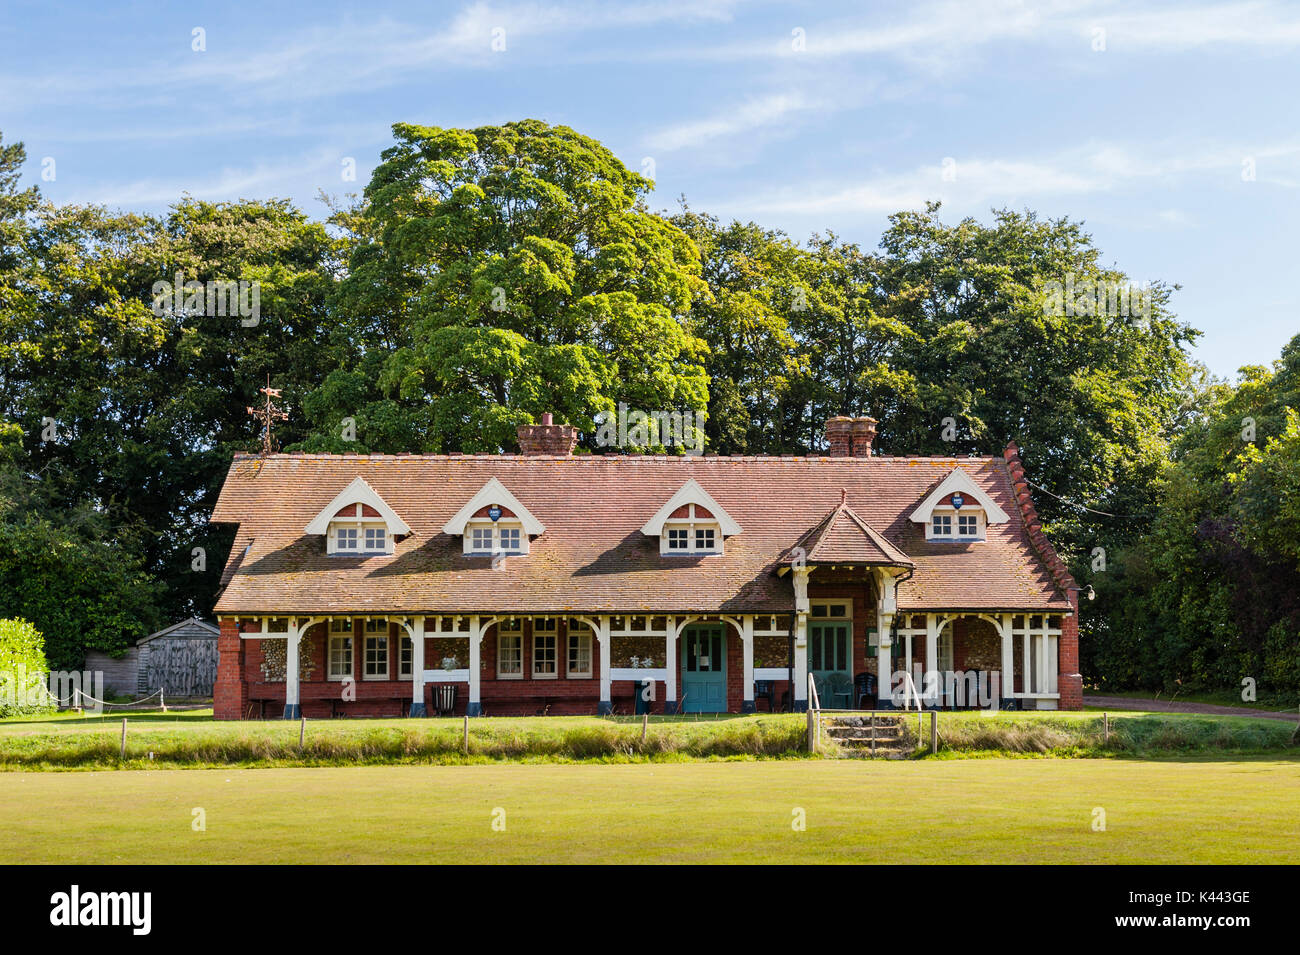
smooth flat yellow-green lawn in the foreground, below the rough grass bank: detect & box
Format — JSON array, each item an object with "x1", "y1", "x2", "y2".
[{"x1": 0, "y1": 759, "x2": 1300, "y2": 864}]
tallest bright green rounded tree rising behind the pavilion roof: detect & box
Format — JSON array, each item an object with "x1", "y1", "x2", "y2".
[{"x1": 303, "y1": 120, "x2": 707, "y2": 451}]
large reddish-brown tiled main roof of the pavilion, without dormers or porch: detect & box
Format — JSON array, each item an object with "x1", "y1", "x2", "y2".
[{"x1": 212, "y1": 455, "x2": 1070, "y2": 615}]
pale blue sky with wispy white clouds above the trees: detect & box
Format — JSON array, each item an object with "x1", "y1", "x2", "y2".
[{"x1": 0, "y1": 0, "x2": 1300, "y2": 377}]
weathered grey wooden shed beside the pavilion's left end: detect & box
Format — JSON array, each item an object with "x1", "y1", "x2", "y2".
[{"x1": 86, "y1": 617, "x2": 220, "y2": 699}]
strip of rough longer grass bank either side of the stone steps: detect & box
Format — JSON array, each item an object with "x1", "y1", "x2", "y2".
[{"x1": 0, "y1": 711, "x2": 1300, "y2": 770}]
